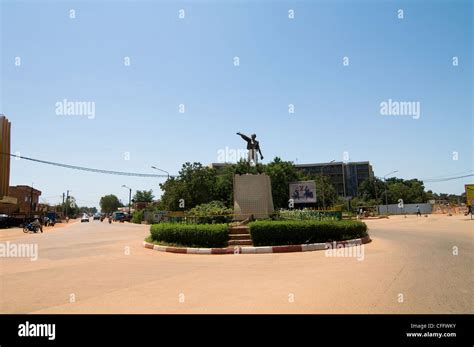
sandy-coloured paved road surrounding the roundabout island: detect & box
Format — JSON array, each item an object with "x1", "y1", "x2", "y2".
[{"x1": 0, "y1": 215, "x2": 474, "y2": 313}]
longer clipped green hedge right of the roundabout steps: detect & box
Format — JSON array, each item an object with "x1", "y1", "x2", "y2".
[{"x1": 249, "y1": 221, "x2": 367, "y2": 246}]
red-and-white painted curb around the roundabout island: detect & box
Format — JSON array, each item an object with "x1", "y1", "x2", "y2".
[{"x1": 143, "y1": 235, "x2": 372, "y2": 254}]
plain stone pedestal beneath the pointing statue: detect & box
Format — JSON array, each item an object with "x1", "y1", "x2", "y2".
[{"x1": 234, "y1": 174, "x2": 274, "y2": 221}]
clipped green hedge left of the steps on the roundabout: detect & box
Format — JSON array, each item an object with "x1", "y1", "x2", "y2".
[{"x1": 150, "y1": 223, "x2": 229, "y2": 248}]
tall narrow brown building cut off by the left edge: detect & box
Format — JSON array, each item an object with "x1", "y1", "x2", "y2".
[{"x1": 0, "y1": 114, "x2": 17, "y2": 213}]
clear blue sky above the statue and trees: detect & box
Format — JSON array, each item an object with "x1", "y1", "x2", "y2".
[{"x1": 0, "y1": 1, "x2": 474, "y2": 206}]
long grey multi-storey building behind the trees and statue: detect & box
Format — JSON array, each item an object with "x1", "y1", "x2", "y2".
[{"x1": 209, "y1": 161, "x2": 374, "y2": 197}]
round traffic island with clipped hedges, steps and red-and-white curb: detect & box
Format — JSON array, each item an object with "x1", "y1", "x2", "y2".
[{"x1": 143, "y1": 220, "x2": 371, "y2": 254}]
